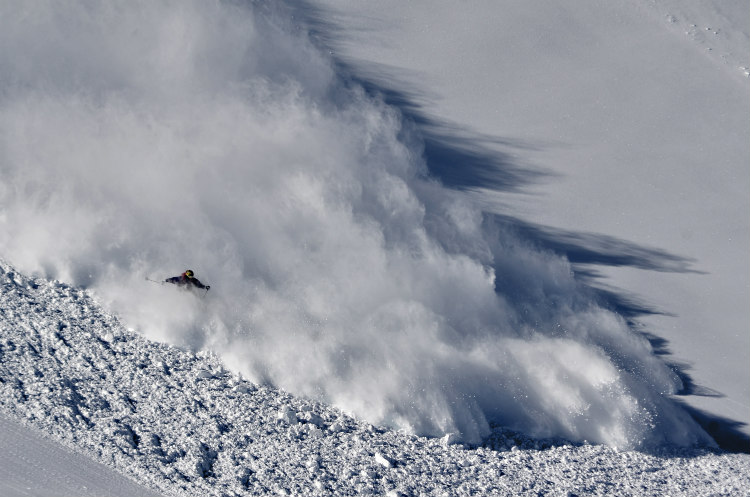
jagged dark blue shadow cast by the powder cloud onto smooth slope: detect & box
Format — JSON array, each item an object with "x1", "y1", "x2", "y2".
[{"x1": 295, "y1": 2, "x2": 750, "y2": 453}]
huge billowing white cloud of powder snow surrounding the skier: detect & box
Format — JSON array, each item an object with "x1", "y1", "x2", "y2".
[{"x1": 0, "y1": 0, "x2": 705, "y2": 447}]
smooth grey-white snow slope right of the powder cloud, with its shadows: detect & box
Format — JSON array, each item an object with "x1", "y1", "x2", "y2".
[{"x1": 312, "y1": 0, "x2": 750, "y2": 444}]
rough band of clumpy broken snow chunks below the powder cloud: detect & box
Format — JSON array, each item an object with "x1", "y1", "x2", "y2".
[{"x1": 0, "y1": 263, "x2": 750, "y2": 496}]
